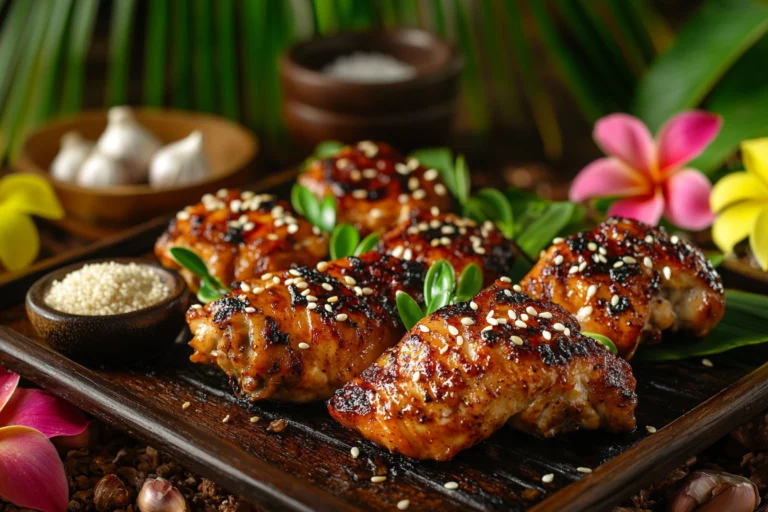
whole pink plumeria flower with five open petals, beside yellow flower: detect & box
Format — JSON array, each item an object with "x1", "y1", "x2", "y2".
[{"x1": 570, "y1": 110, "x2": 721, "y2": 231}]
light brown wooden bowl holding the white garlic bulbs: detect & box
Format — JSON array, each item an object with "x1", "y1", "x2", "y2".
[{"x1": 16, "y1": 108, "x2": 258, "y2": 225}]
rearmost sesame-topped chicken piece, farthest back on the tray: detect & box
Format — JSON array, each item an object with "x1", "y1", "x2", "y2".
[{"x1": 298, "y1": 141, "x2": 450, "y2": 235}]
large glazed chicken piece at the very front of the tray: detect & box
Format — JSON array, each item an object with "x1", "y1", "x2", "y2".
[{"x1": 328, "y1": 279, "x2": 637, "y2": 460}]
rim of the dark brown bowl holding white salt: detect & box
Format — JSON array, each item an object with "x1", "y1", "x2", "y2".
[{"x1": 279, "y1": 28, "x2": 464, "y2": 93}]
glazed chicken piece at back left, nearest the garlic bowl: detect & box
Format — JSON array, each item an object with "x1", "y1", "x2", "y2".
[{"x1": 155, "y1": 190, "x2": 328, "y2": 291}]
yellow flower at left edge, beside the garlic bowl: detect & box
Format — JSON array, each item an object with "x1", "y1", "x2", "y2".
[{"x1": 0, "y1": 174, "x2": 64, "y2": 270}]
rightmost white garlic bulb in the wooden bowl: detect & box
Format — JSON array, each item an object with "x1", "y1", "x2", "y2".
[{"x1": 149, "y1": 131, "x2": 211, "y2": 188}]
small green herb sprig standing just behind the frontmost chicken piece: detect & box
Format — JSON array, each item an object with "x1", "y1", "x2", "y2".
[{"x1": 395, "y1": 260, "x2": 483, "y2": 329}]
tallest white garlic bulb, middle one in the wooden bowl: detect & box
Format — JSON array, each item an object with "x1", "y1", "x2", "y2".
[{"x1": 96, "y1": 107, "x2": 160, "y2": 183}]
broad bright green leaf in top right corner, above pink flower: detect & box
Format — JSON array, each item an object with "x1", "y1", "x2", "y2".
[{"x1": 634, "y1": 0, "x2": 768, "y2": 130}]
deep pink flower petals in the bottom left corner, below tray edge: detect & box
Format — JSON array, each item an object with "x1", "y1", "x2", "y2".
[{"x1": 0, "y1": 366, "x2": 88, "y2": 512}]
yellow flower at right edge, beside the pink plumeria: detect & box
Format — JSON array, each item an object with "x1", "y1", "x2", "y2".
[{"x1": 709, "y1": 137, "x2": 768, "y2": 271}]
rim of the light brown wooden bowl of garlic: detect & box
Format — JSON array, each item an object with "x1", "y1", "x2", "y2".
[{"x1": 12, "y1": 106, "x2": 260, "y2": 197}]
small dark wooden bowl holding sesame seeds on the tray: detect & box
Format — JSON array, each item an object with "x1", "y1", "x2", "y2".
[{"x1": 26, "y1": 258, "x2": 190, "y2": 364}]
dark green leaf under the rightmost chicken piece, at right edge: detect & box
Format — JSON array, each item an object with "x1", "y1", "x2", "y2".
[{"x1": 634, "y1": 290, "x2": 768, "y2": 361}]
